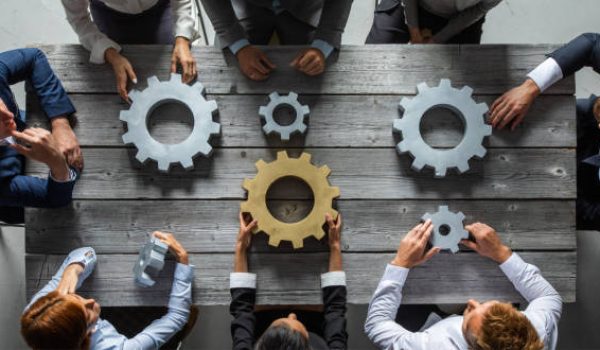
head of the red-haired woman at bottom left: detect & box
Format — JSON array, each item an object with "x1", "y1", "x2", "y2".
[{"x1": 21, "y1": 291, "x2": 100, "y2": 350}]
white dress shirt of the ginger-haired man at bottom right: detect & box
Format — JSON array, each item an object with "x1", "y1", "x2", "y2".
[{"x1": 365, "y1": 253, "x2": 562, "y2": 350}]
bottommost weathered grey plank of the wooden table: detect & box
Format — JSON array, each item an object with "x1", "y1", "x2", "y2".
[{"x1": 26, "y1": 252, "x2": 576, "y2": 306}]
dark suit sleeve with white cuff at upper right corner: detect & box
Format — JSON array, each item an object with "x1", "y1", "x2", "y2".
[{"x1": 548, "y1": 33, "x2": 600, "y2": 77}]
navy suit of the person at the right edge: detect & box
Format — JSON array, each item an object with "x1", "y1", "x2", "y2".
[{"x1": 548, "y1": 33, "x2": 600, "y2": 230}]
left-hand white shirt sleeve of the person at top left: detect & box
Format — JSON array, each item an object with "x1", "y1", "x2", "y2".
[{"x1": 62, "y1": 0, "x2": 121, "y2": 64}]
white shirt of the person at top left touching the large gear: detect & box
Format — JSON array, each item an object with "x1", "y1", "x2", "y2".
[{"x1": 62, "y1": 0, "x2": 197, "y2": 64}]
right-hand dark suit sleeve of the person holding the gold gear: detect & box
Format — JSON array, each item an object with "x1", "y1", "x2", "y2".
[{"x1": 322, "y1": 286, "x2": 348, "y2": 350}]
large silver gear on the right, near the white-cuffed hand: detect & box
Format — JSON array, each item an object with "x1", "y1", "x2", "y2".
[{"x1": 394, "y1": 79, "x2": 492, "y2": 177}]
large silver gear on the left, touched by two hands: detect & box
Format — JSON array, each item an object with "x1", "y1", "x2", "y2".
[{"x1": 119, "y1": 73, "x2": 221, "y2": 172}]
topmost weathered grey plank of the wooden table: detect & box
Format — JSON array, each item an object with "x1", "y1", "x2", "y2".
[{"x1": 36, "y1": 45, "x2": 574, "y2": 94}]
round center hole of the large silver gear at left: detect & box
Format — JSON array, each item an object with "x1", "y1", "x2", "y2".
[{"x1": 146, "y1": 100, "x2": 194, "y2": 145}]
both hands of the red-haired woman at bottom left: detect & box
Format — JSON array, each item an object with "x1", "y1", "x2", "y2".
[{"x1": 56, "y1": 231, "x2": 189, "y2": 295}]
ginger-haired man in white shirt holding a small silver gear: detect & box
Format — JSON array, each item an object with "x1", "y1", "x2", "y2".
[{"x1": 365, "y1": 220, "x2": 562, "y2": 350}]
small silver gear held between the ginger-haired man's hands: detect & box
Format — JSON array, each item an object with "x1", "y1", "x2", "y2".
[{"x1": 422, "y1": 205, "x2": 469, "y2": 253}]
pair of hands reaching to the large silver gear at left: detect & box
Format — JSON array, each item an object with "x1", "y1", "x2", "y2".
[{"x1": 104, "y1": 37, "x2": 198, "y2": 103}]
